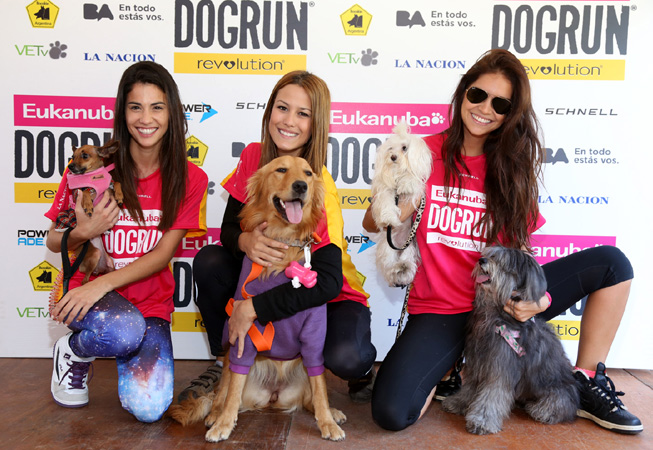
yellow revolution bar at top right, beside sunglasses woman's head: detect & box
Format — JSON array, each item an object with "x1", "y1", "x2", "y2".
[{"x1": 521, "y1": 59, "x2": 626, "y2": 81}]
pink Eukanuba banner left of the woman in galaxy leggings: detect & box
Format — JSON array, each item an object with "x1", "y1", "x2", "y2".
[{"x1": 14, "y1": 95, "x2": 116, "y2": 128}]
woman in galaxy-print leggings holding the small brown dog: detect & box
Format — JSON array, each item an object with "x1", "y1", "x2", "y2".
[{"x1": 46, "y1": 62, "x2": 208, "y2": 422}]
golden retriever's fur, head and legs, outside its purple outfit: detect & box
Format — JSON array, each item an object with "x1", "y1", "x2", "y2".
[{"x1": 169, "y1": 156, "x2": 347, "y2": 442}]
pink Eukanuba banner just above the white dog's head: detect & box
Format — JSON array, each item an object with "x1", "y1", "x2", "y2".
[{"x1": 329, "y1": 102, "x2": 449, "y2": 134}]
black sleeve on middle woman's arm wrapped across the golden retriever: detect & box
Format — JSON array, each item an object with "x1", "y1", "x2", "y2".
[{"x1": 252, "y1": 244, "x2": 343, "y2": 324}]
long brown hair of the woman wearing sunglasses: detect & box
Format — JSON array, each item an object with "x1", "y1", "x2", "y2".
[{"x1": 442, "y1": 49, "x2": 544, "y2": 249}]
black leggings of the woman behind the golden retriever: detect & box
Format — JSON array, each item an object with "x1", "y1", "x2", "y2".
[{"x1": 193, "y1": 245, "x2": 376, "y2": 380}]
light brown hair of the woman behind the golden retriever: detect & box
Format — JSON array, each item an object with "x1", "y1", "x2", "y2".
[{"x1": 259, "y1": 70, "x2": 331, "y2": 177}]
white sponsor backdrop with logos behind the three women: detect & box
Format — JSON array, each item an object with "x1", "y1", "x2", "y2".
[{"x1": 0, "y1": 0, "x2": 653, "y2": 369}]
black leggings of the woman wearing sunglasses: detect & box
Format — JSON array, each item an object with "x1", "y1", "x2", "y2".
[{"x1": 372, "y1": 246, "x2": 633, "y2": 431}]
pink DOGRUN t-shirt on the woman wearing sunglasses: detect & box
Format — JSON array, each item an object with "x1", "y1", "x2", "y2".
[{"x1": 408, "y1": 134, "x2": 544, "y2": 314}]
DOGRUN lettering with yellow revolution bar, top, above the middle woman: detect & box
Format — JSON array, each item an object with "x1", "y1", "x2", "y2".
[{"x1": 174, "y1": 0, "x2": 309, "y2": 75}]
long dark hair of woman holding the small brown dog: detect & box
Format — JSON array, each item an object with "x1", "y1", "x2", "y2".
[{"x1": 113, "y1": 61, "x2": 188, "y2": 230}]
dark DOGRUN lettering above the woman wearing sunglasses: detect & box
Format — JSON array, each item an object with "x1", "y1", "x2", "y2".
[{"x1": 492, "y1": 5, "x2": 630, "y2": 55}]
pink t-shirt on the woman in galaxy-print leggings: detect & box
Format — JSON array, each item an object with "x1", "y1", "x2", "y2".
[{"x1": 45, "y1": 162, "x2": 208, "y2": 321}]
